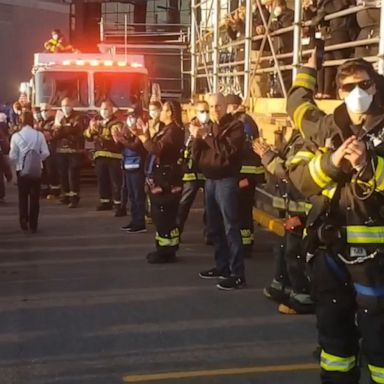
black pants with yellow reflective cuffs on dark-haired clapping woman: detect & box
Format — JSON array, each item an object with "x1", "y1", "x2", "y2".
[{"x1": 150, "y1": 193, "x2": 181, "y2": 255}]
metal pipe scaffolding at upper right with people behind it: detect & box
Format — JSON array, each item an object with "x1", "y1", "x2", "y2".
[{"x1": 190, "y1": 0, "x2": 384, "y2": 100}]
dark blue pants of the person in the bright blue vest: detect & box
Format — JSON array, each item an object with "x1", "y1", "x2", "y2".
[{"x1": 123, "y1": 171, "x2": 145, "y2": 227}]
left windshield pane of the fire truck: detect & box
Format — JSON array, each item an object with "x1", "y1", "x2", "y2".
[{"x1": 35, "y1": 71, "x2": 88, "y2": 107}]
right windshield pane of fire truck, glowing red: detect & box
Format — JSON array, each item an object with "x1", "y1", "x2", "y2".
[{"x1": 94, "y1": 72, "x2": 147, "y2": 108}]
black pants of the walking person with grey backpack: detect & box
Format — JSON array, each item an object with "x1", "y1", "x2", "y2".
[{"x1": 17, "y1": 176, "x2": 41, "y2": 230}]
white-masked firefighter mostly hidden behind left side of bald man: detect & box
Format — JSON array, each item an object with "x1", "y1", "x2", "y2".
[{"x1": 177, "y1": 101, "x2": 210, "y2": 242}]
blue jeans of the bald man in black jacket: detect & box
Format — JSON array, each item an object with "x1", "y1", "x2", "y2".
[{"x1": 205, "y1": 177, "x2": 244, "y2": 277}]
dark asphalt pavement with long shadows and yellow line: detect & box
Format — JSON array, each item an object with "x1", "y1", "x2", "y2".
[{"x1": 0, "y1": 185, "x2": 319, "y2": 384}]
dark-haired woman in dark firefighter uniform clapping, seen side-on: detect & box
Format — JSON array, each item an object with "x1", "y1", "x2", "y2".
[{"x1": 131, "y1": 101, "x2": 184, "y2": 264}]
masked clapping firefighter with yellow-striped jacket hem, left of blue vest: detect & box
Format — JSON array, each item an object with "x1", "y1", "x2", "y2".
[{"x1": 84, "y1": 101, "x2": 123, "y2": 217}]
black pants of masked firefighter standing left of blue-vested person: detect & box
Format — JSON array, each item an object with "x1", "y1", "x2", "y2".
[{"x1": 95, "y1": 157, "x2": 123, "y2": 205}]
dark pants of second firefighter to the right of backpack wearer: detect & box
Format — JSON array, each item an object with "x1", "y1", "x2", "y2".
[{"x1": 57, "y1": 153, "x2": 82, "y2": 198}]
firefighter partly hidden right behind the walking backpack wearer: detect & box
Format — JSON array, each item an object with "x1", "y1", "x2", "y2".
[{"x1": 38, "y1": 103, "x2": 60, "y2": 200}]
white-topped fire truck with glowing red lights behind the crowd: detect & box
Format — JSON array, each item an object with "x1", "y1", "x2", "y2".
[{"x1": 21, "y1": 53, "x2": 149, "y2": 112}]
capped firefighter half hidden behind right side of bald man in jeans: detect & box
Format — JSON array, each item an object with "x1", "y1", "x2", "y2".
[{"x1": 226, "y1": 95, "x2": 264, "y2": 257}]
